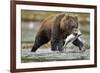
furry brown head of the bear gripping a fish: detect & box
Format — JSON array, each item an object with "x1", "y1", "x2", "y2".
[{"x1": 60, "y1": 15, "x2": 78, "y2": 35}]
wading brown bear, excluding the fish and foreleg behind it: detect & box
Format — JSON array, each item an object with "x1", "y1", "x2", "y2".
[{"x1": 31, "y1": 13, "x2": 78, "y2": 52}]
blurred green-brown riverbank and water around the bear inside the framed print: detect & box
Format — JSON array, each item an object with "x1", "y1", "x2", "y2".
[{"x1": 21, "y1": 10, "x2": 90, "y2": 62}]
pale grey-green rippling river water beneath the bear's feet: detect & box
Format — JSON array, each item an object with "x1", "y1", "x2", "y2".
[{"x1": 21, "y1": 48, "x2": 90, "y2": 63}]
